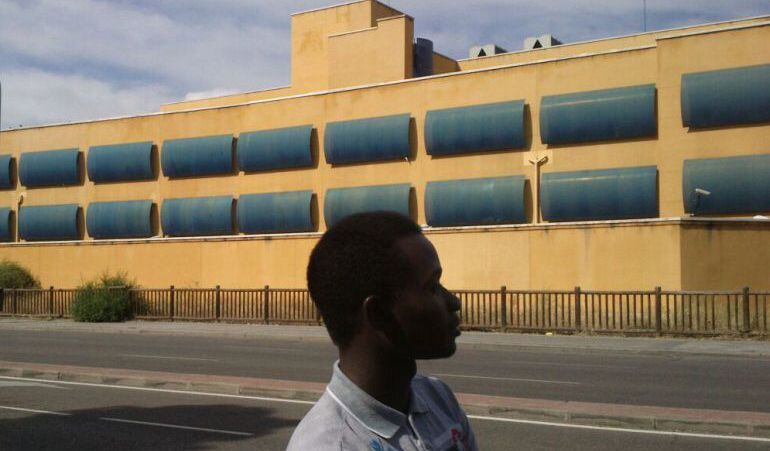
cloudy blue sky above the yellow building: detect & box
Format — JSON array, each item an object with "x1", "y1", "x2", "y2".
[{"x1": 0, "y1": 0, "x2": 770, "y2": 129}]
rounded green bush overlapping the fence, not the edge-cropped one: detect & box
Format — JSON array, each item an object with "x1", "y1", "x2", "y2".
[{"x1": 72, "y1": 273, "x2": 135, "y2": 323}]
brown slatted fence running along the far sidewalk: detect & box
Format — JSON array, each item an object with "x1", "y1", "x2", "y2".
[{"x1": 0, "y1": 286, "x2": 770, "y2": 335}]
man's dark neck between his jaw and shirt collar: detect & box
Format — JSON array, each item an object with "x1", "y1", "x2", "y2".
[{"x1": 340, "y1": 349, "x2": 417, "y2": 413}]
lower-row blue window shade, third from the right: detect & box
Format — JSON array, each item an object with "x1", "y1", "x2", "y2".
[{"x1": 425, "y1": 176, "x2": 527, "y2": 227}]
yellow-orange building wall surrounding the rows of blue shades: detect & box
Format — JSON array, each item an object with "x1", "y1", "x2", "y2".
[{"x1": 0, "y1": 5, "x2": 770, "y2": 289}]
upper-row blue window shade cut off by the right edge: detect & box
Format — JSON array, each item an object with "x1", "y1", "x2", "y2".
[{"x1": 680, "y1": 64, "x2": 770, "y2": 128}]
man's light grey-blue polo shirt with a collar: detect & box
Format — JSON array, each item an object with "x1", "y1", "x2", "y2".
[{"x1": 287, "y1": 363, "x2": 478, "y2": 451}]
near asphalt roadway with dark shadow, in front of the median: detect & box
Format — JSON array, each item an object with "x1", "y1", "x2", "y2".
[{"x1": 0, "y1": 377, "x2": 769, "y2": 451}]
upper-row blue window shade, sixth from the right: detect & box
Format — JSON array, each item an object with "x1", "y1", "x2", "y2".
[{"x1": 161, "y1": 135, "x2": 233, "y2": 177}]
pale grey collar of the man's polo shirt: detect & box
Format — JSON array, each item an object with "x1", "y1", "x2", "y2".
[{"x1": 326, "y1": 361, "x2": 428, "y2": 439}]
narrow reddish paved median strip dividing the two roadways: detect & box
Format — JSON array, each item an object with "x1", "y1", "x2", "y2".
[{"x1": 0, "y1": 362, "x2": 770, "y2": 438}]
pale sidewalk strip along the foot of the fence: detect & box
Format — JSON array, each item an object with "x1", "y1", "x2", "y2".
[{"x1": 0, "y1": 318, "x2": 770, "y2": 357}]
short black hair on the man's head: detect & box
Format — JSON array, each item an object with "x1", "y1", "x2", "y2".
[{"x1": 307, "y1": 211, "x2": 422, "y2": 347}]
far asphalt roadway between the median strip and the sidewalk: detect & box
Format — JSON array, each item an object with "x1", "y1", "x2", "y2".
[{"x1": 0, "y1": 330, "x2": 770, "y2": 412}]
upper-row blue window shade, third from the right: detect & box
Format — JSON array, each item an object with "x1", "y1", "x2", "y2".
[{"x1": 425, "y1": 100, "x2": 525, "y2": 155}]
